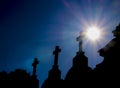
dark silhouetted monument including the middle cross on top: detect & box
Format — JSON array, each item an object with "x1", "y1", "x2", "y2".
[{"x1": 42, "y1": 46, "x2": 63, "y2": 88}]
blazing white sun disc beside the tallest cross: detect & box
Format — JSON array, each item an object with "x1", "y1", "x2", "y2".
[{"x1": 85, "y1": 26, "x2": 101, "y2": 41}]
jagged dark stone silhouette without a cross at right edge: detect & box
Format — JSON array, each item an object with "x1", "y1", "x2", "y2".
[{"x1": 94, "y1": 24, "x2": 120, "y2": 87}]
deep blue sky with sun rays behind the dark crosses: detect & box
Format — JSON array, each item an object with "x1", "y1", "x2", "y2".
[{"x1": 0, "y1": 0, "x2": 120, "y2": 85}]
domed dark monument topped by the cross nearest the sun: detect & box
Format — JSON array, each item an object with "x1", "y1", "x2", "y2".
[{"x1": 65, "y1": 33, "x2": 92, "y2": 88}]
